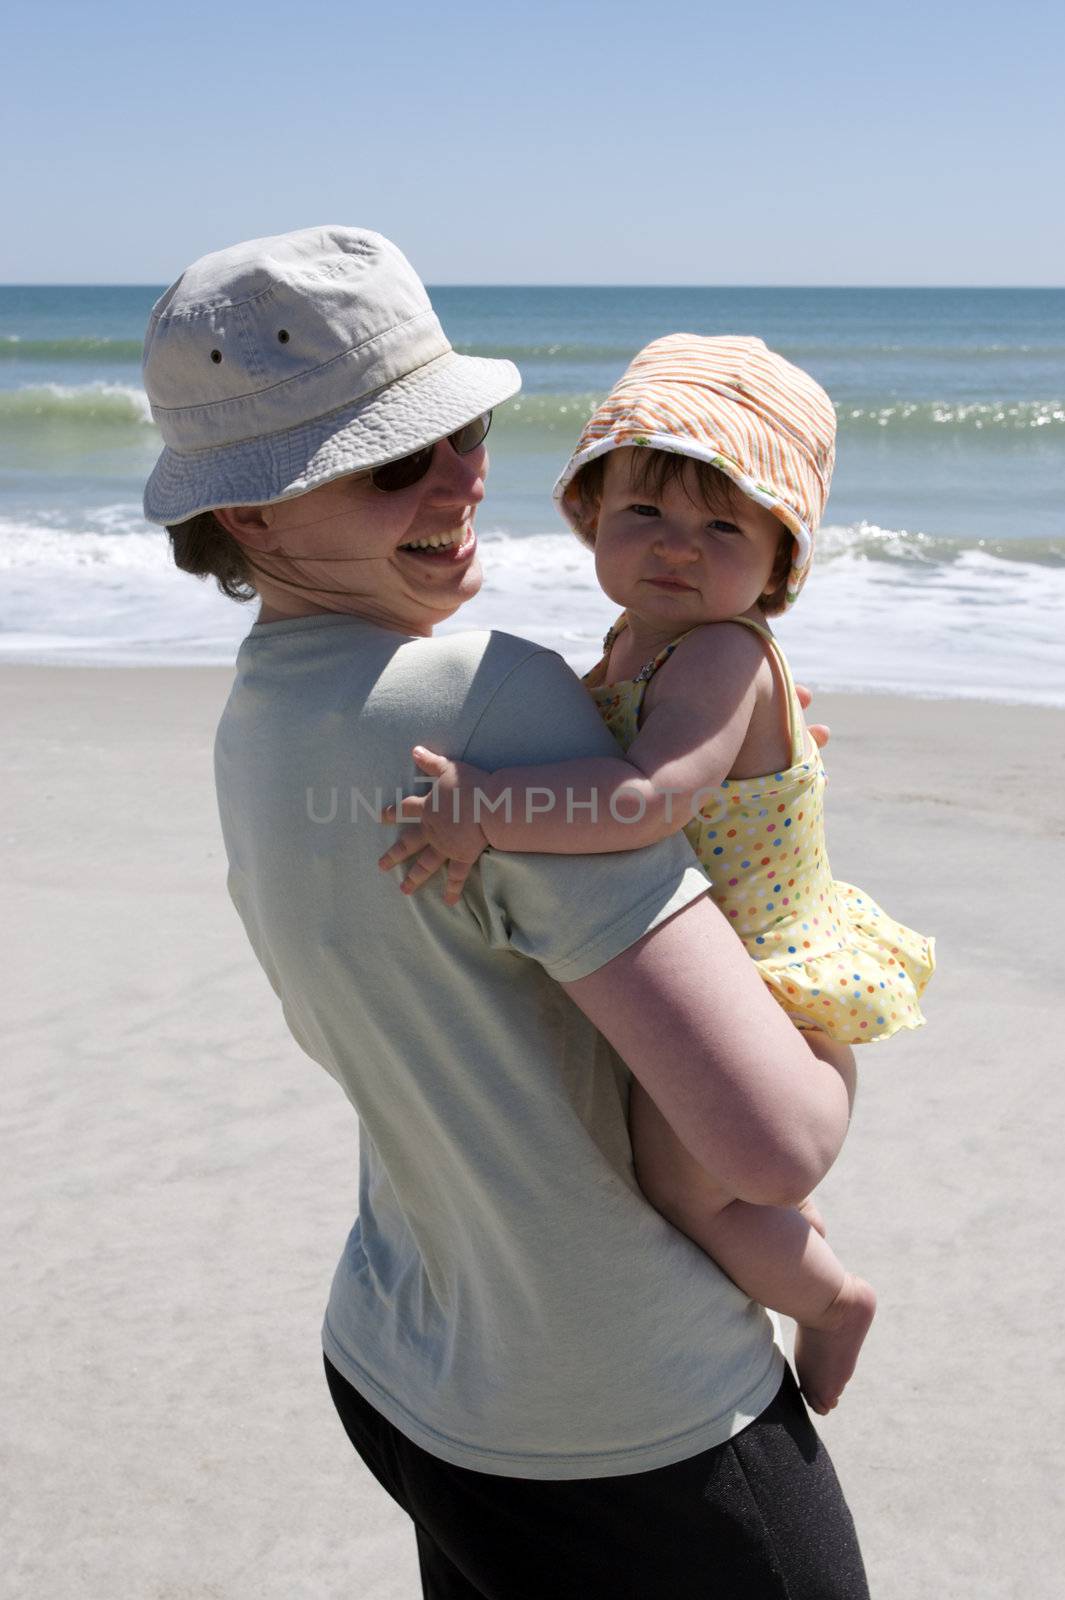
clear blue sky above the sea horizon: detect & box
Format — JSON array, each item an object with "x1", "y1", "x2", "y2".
[{"x1": 0, "y1": 0, "x2": 1065, "y2": 285}]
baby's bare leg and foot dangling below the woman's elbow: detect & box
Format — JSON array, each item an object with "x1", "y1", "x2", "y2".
[{"x1": 630, "y1": 1046, "x2": 876, "y2": 1413}]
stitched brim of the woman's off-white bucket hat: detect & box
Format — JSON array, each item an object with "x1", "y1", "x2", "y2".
[{"x1": 144, "y1": 350, "x2": 521, "y2": 523}]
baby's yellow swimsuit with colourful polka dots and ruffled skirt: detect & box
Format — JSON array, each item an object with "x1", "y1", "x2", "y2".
[{"x1": 584, "y1": 616, "x2": 935, "y2": 1045}]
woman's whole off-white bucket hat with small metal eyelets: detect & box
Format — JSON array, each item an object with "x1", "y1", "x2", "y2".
[{"x1": 144, "y1": 227, "x2": 521, "y2": 523}]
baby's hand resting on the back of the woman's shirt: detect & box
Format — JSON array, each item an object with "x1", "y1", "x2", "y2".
[{"x1": 377, "y1": 744, "x2": 488, "y2": 906}]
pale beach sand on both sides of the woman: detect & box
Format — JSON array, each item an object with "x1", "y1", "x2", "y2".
[{"x1": 0, "y1": 667, "x2": 1065, "y2": 1600}]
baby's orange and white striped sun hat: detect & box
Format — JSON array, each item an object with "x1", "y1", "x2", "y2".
[{"x1": 555, "y1": 333, "x2": 836, "y2": 605}]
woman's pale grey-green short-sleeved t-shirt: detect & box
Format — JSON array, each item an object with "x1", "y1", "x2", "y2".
[{"x1": 216, "y1": 616, "x2": 782, "y2": 1478}]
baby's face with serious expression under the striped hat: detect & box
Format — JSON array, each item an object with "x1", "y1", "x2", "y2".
[{"x1": 595, "y1": 450, "x2": 785, "y2": 627}]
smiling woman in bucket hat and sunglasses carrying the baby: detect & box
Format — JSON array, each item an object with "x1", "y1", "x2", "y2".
[{"x1": 144, "y1": 227, "x2": 867, "y2": 1600}]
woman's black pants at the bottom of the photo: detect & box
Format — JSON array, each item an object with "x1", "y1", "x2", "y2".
[{"x1": 326, "y1": 1360, "x2": 868, "y2": 1600}]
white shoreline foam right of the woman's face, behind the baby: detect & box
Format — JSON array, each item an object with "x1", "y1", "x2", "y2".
[{"x1": 448, "y1": 525, "x2": 1065, "y2": 706}]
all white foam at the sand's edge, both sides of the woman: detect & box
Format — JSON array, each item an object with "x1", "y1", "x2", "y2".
[{"x1": 0, "y1": 521, "x2": 1065, "y2": 706}]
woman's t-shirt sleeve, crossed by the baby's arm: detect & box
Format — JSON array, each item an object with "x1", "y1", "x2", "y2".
[{"x1": 462, "y1": 650, "x2": 707, "y2": 982}]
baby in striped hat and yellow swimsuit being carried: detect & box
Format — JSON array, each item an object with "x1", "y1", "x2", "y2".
[{"x1": 381, "y1": 334, "x2": 934, "y2": 1413}]
